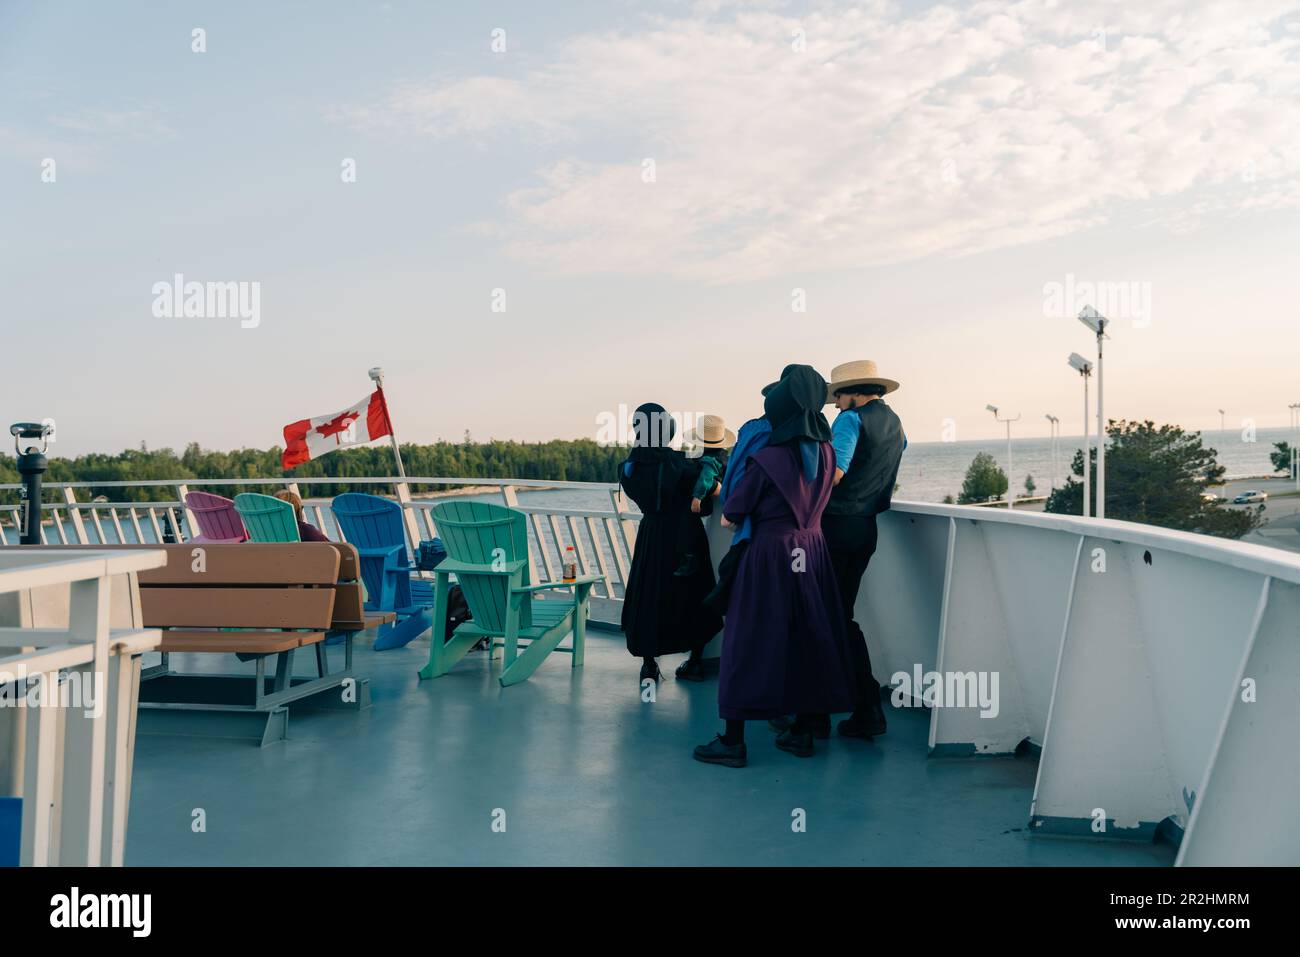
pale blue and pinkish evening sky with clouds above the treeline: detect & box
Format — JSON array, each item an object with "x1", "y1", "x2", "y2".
[{"x1": 0, "y1": 0, "x2": 1300, "y2": 455}]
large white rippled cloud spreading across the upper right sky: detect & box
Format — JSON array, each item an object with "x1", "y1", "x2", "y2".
[{"x1": 335, "y1": 0, "x2": 1300, "y2": 282}]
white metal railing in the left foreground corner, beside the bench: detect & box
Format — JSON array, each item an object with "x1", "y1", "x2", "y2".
[{"x1": 0, "y1": 549, "x2": 166, "y2": 866}]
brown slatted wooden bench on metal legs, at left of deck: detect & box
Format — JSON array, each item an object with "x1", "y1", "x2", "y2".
[{"x1": 20, "y1": 542, "x2": 393, "y2": 745}]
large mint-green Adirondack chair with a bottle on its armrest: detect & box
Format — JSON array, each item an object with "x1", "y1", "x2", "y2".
[{"x1": 420, "y1": 502, "x2": 605, "y2": 687}]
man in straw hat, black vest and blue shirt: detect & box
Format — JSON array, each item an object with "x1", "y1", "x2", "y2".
[{"x1": 822, "y1": 359, "x2": 907, "y2": 740}]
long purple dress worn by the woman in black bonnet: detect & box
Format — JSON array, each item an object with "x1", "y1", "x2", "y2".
[{"x1": 718, "y1": 442, "x2": 858, "y2": 720}]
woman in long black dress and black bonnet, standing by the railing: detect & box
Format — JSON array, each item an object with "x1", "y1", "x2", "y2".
[{"x1": 619, "y1": 403, "x2": 723, "y2": 681}]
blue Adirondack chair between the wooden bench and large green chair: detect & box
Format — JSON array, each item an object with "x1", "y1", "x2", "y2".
[{"x1": 333, "y1": 492, "x2": 434, "y2": 651}]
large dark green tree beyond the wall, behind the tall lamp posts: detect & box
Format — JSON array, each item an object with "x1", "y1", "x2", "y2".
[{"x1": 1047, "y1": 420, "x2": 1264, "y2": 538}]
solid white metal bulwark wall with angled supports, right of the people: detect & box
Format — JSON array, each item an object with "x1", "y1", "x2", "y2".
[{"x1": 857, "y1": 502, "x2": 1300, "y2": 865}]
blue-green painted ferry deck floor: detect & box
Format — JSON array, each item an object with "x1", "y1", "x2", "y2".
[{"x1": 126, "y1": 628, "x2": 1175, "y2": 866}]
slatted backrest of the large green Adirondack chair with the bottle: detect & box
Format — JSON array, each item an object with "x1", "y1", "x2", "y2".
[{"x1": 432, "y1": 502, "x2": 532, "y2": 632}]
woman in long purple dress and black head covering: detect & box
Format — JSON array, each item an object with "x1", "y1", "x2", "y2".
[{"x1": 696, "y1": 365, "x2": 857, "y2": 767}]
